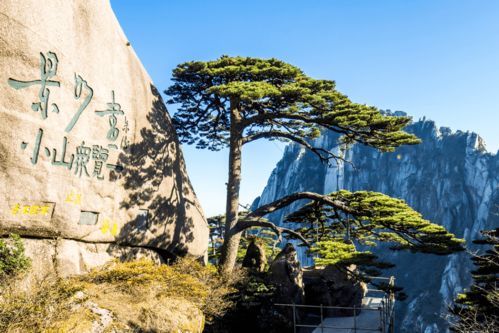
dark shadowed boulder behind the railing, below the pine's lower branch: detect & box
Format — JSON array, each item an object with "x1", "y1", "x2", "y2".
[{"x1": 303, "y1": 265, "x2": 367, "y2": 316}]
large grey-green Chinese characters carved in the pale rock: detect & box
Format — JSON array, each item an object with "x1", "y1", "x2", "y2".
[{"x1": 8, "y1": 51, "x2": 129, "y2": 181}]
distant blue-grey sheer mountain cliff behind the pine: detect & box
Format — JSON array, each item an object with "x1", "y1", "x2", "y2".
[{"x1": 253, "y1": 113, "x2": 499, "y2": 333}]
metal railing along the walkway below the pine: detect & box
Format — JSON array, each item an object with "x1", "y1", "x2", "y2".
[{"x1": 274, "y1": 276, "x2": 395, "y2": 333}]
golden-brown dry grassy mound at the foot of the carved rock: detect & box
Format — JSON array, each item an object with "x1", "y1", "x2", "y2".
[{"x1": 0, "y1": 259, "x2": 234, "y2": 333}]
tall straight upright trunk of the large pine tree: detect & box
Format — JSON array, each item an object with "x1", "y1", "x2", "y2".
[{"x1": 220, "y1": 100, "x2": 242, "y2": 273}]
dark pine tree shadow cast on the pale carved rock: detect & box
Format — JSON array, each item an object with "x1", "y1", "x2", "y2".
[{"x1": 111, "y1": 85, "x2": 203, "y2": 258}]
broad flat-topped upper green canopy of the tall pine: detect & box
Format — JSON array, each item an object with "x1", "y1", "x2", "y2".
[{"x1": 165, "y1": 56, "x2": 420, "y2": 160}]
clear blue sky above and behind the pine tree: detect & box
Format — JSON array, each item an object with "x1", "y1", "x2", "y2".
[{"x1": 111, "y1": 0, "x2": 499, "y2": 216}]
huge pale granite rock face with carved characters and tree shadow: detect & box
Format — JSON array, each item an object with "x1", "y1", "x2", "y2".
[{"x1": 0, "y1": 0, "x2": 208, "y2": 273}]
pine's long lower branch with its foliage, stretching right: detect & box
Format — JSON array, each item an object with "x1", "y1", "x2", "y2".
[{"x1": 247, "y1": 190, "x2": 464, "y2": 275}]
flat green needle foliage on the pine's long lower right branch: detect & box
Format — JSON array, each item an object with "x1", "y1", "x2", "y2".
[{"x1": 286, "y1": 190, "x2": 464, "y2": 254}]
